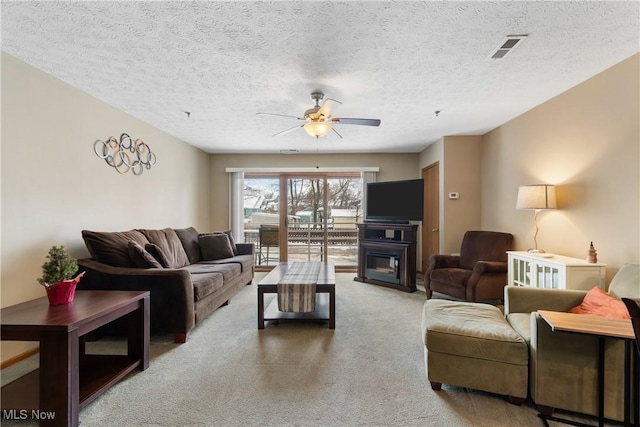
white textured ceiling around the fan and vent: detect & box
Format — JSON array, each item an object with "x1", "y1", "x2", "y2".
[{"x1": 2, "y1": 0, "x2": 640, "y2": 153}]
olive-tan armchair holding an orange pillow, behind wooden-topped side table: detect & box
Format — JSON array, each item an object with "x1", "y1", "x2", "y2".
[{"x1": 504, "y1": 264, "x2": 640, "y2": 421}]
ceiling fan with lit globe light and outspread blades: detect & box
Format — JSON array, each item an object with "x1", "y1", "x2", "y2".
[{"x1": 256, "y1": 91, "x2": 380, "y2": 139}]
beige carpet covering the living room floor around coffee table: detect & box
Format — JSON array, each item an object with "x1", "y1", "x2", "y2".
[{"x1": 2, "y1": 273, "x2": 608, "y2": 427}]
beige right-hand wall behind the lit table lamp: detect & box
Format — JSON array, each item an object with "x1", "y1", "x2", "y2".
[{"x1": 482, "y1": 54, "x2": 640, "y2": 286}]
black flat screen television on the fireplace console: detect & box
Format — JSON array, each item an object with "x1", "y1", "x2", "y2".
[{"x1": 365, "y1": 179, "x2": 424, "y2": 222}]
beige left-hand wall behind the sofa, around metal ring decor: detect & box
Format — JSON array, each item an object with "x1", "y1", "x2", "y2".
[{"x1": 0, "y1": 53, "x2": 210, "y2": 361}]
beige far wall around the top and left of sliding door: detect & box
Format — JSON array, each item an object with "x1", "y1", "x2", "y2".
[{"x1": 211, "y1": 153, "x2": 420, "y2": 230}]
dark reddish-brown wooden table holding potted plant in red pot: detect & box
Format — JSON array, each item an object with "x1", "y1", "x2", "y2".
[{"x1": 0, "y1": 291, "x2": 149, "y2": 427}]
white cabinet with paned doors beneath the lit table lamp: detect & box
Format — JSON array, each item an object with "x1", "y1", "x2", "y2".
[{"x1": 507, "y1": 251, "x2": 606, "y2": 290}]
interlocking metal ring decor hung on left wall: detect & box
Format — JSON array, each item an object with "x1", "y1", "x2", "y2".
[{"x1": 93, "y1": 133, "x2": 156, "y2": 175}]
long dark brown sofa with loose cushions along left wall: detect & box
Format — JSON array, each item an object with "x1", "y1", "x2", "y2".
[{"x1": 77, "y1": 227, "x2": 255, "y2": 342}]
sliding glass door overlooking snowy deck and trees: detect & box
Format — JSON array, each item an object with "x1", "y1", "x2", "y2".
[{"x1": 244, "y1": 173, "x2": 363, "y2": 267}]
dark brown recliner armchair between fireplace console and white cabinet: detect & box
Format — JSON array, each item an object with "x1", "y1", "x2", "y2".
[{"x1": 424, "y1": 231, "x2": 513, "y2": 302}]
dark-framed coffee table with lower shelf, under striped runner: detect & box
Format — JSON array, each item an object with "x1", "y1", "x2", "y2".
[{"x1": 258, "y1": 262, "x2": 336, "y2": 329}]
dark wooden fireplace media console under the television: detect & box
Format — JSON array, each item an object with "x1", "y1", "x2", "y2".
[{"x1": 354, "y1": 222, "x2": 418, "y2": 292}]
